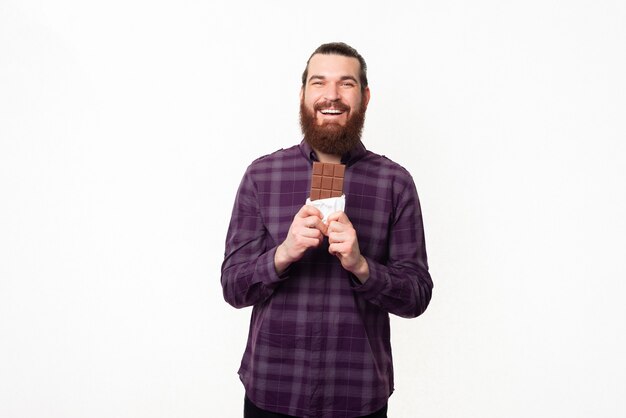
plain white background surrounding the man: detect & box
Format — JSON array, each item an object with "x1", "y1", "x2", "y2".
[{"x1": 0, "y1": 0, "x2": 626, "y2": 418}]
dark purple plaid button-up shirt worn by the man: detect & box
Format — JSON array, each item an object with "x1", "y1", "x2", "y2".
[{"x1": 222, "y1": 141, "x2": 432, "y2": 418}]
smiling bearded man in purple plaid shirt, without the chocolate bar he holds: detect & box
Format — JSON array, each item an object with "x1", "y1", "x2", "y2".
[{"x1": 222, "y1": 43, "x2": 432, "y2": 418}]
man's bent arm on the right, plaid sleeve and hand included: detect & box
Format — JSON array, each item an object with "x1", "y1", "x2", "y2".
[{"x1": 328, "y1": 181, "x2": 433, "y2": 318}]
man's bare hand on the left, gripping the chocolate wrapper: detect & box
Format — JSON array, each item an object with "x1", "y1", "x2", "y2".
[{"x1": 274, "y1": 205, "x2": 327, "y2": 274}]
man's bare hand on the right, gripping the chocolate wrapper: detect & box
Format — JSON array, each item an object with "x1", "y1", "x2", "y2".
[{"x1": 326, "y1": 211, "x2": 369, "y2": 283}]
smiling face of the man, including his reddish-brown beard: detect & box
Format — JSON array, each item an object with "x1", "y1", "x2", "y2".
[{"x1": 300, "y1": 54, "x2": 370, "y2": 156}]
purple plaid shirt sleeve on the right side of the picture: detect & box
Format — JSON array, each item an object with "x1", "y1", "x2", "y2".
[{"x1": 354, "y1": 180, "x2": 433, "y2": 318}]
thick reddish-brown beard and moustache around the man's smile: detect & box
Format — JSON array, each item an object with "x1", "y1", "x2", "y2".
[{"x1": 300, "y1": 100, "x2": 366, "y2": 156}]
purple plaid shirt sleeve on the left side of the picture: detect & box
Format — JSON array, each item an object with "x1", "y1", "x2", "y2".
[{"x1": 221, "y1": 168, "x2": 289, "y2": 308}]
